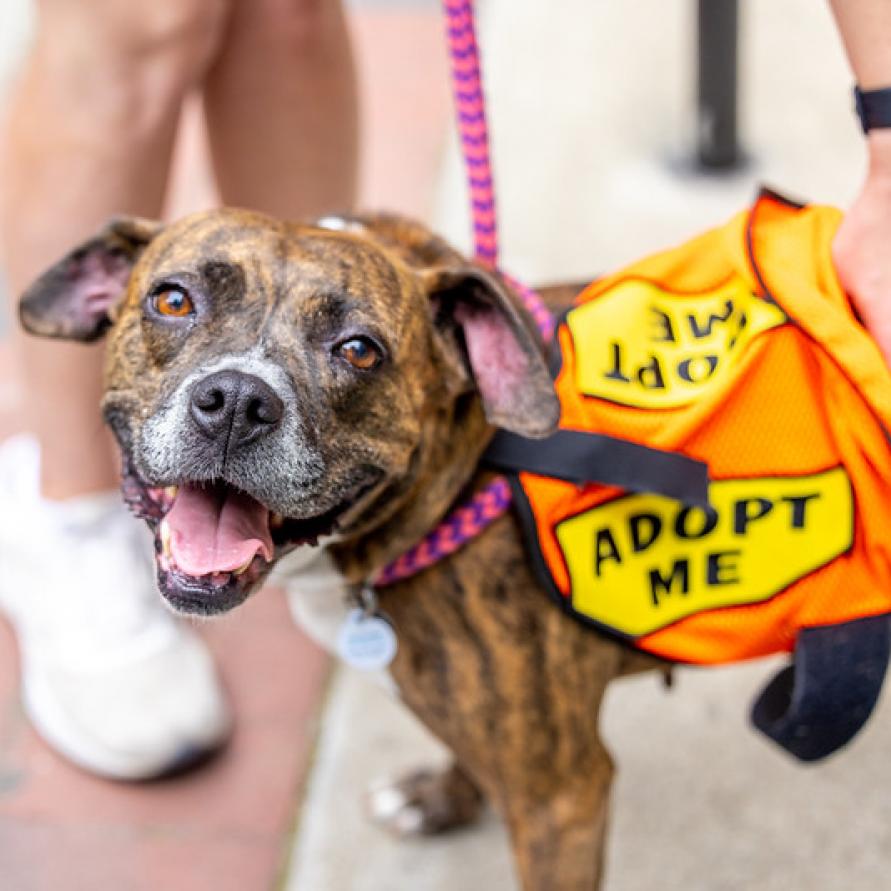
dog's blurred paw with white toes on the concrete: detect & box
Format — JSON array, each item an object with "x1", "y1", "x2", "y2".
[{"x1": 366, "y1": 768, "x2": 483, "y2": 838}]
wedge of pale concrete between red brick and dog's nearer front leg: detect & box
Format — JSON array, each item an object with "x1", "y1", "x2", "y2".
[{"x1": 286, "y1": 669, "x2": 514, "y2": 891}]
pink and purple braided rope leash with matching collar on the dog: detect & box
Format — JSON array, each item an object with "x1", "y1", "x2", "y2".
[{"x1": 374, "y1": 0, "x2": 554, "y2": 587}]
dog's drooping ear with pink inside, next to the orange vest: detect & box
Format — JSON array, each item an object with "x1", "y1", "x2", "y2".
[{"x1": 423, "y1": 264, "x2": 560, "y2": 437}]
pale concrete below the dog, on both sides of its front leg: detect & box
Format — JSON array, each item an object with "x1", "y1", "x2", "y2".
[{"x1": 286, "y1": 660, "x2": 891, "y2": 891}]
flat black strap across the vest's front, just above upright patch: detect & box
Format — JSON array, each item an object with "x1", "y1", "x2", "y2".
[{"x1": 483, "y1": 430, "x2": 708, "y2": 507}]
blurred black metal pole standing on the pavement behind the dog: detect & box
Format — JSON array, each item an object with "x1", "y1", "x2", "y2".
[{"x1": 697, "y1": 0, "x2": 740, "y2": 169}]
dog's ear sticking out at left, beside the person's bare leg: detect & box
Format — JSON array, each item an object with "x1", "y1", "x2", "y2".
[{"x1": 19, "y1": 217, "x2": 161, "y2": 341}]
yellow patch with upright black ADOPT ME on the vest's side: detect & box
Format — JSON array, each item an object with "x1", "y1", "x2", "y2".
[{"x1": 555, "y1": 467, "x2": 854, "y2": 637}]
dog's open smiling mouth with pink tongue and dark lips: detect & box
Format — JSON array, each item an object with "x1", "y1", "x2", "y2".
[{"x1": 123, "y1": 470, "x2": 373, "y2": 615}]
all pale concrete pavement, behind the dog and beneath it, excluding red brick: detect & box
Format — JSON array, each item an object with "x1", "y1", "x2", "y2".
[{"x1": 288, "y1": 0, "x2": 891, "y2": 891}]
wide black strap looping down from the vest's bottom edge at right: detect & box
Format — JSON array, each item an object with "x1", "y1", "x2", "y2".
[{"x1": 752, "y1": 613, "x2": 891, "y2": 761}]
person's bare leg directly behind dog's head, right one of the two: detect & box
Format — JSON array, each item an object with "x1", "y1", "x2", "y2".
[{"x1": 204, "y1": 0, "x2": 358, "y2": 218}]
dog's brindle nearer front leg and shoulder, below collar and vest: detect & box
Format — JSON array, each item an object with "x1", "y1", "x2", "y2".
[{"x1": 381, "y1": 518, "x2": 624, "y2": 891}]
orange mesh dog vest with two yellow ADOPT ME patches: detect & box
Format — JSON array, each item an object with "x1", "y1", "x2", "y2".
[{"x1": 484, "y1": 192, "x2": 891, "y2": 760}]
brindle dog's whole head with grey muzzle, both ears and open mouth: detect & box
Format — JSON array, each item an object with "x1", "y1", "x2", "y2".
[{"x1": 21, "y1": 210, "x2": 557, "y2": 614}]
